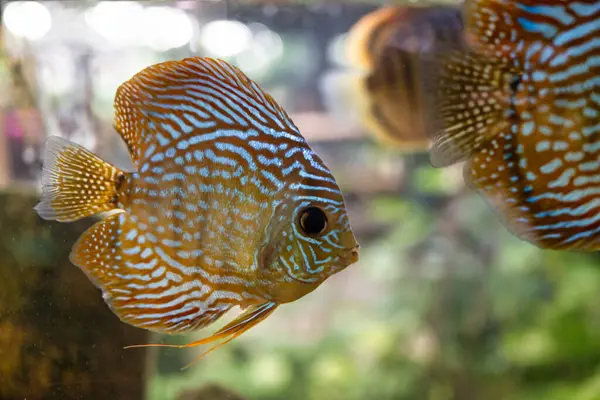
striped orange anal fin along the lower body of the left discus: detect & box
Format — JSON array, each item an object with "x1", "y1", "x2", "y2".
[{"x1": 70, "y1": 212, "x2": 232, "y2": 333}]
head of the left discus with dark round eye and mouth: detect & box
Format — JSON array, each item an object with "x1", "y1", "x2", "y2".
[{"x1": 260, "y1": 155, "x2": 359, "y2": 302}]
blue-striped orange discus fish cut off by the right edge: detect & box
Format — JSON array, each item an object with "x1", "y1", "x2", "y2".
[{"x1": 422, "y1": 0, "x2": 600, "y2": 251}]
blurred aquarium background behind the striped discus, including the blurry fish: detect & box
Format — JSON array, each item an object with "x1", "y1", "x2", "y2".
[{"x1": 0, "y1": 0, "x2": 600, "y2": 400}]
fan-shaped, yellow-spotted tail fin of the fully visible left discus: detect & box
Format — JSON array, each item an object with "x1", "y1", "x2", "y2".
[{"x1": 34, "y1": 136, "x2": 124, "y2": 222}]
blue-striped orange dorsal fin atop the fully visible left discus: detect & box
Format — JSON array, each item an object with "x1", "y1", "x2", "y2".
[{"x1": 115, "y1": 57, "x2": 303, "y2": 166}]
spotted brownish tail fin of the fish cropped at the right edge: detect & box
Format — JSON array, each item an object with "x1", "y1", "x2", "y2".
[{"x1": 423, "y1": 50, "x2": 515, "y2": 167}]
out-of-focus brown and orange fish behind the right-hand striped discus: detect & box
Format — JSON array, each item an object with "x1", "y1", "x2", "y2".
[{"x1": 346, "y1": 6, "x2": 463, "y2": 151}]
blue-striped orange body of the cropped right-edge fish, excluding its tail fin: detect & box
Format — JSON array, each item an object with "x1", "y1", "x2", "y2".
[{"x1": 466, "y1": 0, "x2": 600, "y2": 251}]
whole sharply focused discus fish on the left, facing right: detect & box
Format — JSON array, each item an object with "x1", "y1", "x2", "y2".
[{"x1": 35, "y1": 57, "x2": 359, "y2": 357}]
